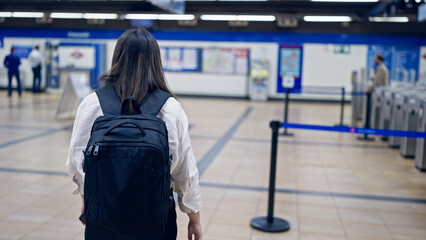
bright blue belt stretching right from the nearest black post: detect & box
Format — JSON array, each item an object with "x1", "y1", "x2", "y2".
[{"x1": 281, "y1": 122, "x2": 426, "y2": 138}]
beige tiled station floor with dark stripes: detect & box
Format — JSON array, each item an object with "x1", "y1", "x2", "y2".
[{"x1": 0, "y1": 91, "x2": 426, "y2": 240}]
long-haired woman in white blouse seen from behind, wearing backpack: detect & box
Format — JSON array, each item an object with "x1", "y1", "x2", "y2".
[{"x1": 66, "y1": 28, "x2": 202, "y2": 240}]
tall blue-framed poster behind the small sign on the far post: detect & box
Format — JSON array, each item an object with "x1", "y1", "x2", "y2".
[{"x1": 277, "y1": 45, "x2": 303, "y2": 93}]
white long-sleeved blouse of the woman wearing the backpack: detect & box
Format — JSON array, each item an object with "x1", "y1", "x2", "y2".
[{"x1": 66, "y1": 93, "x2": 201, "y2": 213}]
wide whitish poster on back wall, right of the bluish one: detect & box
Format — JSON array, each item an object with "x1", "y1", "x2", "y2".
[{"x1": 203, "y1": 48, "x2": 249, "y2": 74}]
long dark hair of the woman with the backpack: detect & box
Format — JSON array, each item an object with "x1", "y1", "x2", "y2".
[{"x1": 99, "y1": 28, "x2": 173, "y2": 104}]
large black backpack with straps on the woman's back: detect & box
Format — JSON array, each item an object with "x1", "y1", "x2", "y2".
[{"x1": 83, "y1": 86, "x2": 172, "y2": 239}]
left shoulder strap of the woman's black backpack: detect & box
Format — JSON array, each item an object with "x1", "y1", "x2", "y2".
[{"x1": 96, "y1": 85, "x2": 121, "y2": 116}]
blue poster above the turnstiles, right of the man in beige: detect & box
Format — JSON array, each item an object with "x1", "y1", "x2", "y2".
[{"x1": 391, "y1": 47, "x2": 420, "y2": 82}]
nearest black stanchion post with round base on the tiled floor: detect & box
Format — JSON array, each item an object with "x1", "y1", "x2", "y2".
[{"x1": 250, "y1": 121, "x2": 290, "y2": 232}]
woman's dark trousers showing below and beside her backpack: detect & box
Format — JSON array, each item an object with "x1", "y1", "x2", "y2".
[{"x1": 84, "y1": 201, "x2": 177, "y2": 240}]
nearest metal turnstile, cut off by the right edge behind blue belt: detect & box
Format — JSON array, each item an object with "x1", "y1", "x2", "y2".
[{"x1": 415, "y1": 98, "x2": 426, "y2": 172}]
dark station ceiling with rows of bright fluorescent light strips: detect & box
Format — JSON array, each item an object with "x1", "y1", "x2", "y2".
[{"x1": 0, "y1": 0, "x2": 426, "y2": 35}]
